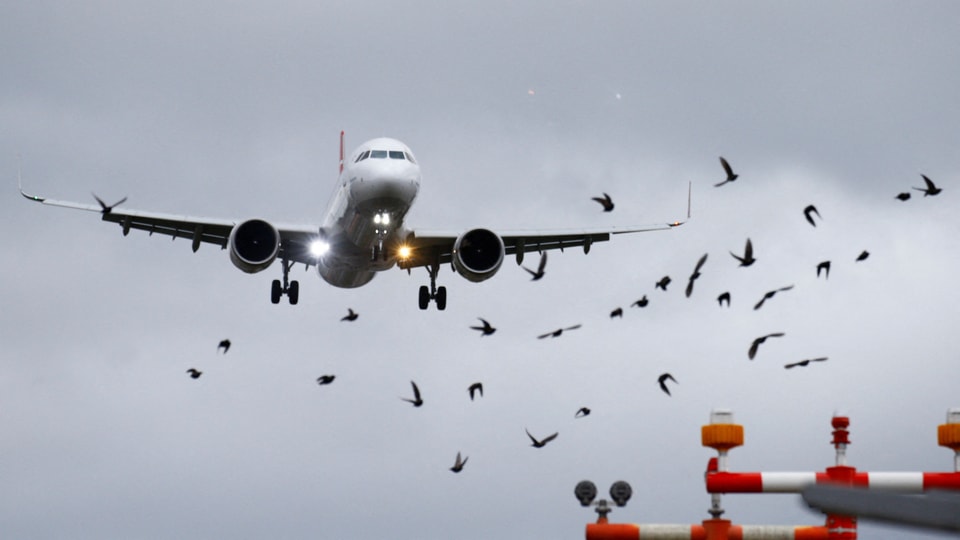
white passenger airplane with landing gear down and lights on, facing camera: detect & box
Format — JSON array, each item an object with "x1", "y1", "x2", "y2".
[{"x1": 18, "y1": 131, "x2": 690, "y2": 311}]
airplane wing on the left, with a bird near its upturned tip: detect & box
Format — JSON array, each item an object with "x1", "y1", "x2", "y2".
[{"x1": 20, "y1": 187, "x2": 319, "y2": 266}]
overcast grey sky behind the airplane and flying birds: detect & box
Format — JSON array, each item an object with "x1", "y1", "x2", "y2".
[{"x1": 0, "y1": 1, "x2": 960, "y2": 539}]
